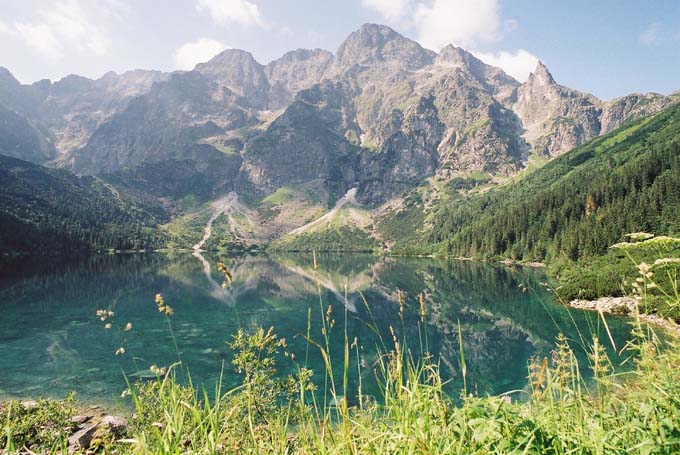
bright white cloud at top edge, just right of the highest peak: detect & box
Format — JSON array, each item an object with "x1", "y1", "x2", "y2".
[{"x1": 415, "y1": 0, "x2": 500, "y2": 51}]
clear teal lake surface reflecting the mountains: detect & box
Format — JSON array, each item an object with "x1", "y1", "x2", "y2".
[{"x1": 0, "y1": 253, "x2": 629, "y2": 402}]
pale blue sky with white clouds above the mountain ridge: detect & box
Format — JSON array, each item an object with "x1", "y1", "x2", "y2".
[{"x1": 0, "y1": 0, "x2": 680, "y2": 99}]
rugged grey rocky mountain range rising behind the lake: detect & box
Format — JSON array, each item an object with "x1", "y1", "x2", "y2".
[{"x1": 0, "y1": 24, "x2": 675, "y2": 253}]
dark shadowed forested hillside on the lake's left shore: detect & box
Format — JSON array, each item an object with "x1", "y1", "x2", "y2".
[{"x1": 0, "y1": 155, "x2": 165, "y2": 255}]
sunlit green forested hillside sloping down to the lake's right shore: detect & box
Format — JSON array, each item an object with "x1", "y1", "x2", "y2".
[{"x1": 427, "y1": 102, "x2": 680, "y2": 261}]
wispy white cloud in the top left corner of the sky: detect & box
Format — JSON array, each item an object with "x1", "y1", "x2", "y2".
[{"x1": 6, "y1": 0, "x2": 116, "y2": 58}]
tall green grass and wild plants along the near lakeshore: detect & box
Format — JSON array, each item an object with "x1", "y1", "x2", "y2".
[{"x1": 0, "y1": 256, "x2": 680, "y2": 454}]
